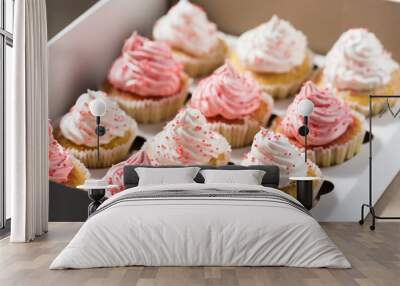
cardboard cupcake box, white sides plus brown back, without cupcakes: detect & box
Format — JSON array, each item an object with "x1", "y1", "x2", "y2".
[{"x1": 49, "y1": 0, "x2": 400, "y2": 221}]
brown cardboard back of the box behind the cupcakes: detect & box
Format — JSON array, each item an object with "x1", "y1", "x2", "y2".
[{"x1": 171, "y1": 0, "x2": 400, "y2": 61}]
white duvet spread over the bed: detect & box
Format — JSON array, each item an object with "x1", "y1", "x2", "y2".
[{"x1": 50, "y1": 184, "x2": 350, "y2": 269}]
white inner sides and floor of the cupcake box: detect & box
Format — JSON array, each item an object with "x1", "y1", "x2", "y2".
[{"x1": 48, "y1": 0, "x2": 400, "y2": 221}]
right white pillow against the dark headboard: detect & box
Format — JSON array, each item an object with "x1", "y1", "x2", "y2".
[{"x1": 200, "y1": 169, "x2": 265, "y2": 185}]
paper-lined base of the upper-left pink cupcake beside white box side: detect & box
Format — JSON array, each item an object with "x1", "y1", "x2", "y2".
[{"x1": 109, "y1": 75, "x2": 189, "y2": 123}]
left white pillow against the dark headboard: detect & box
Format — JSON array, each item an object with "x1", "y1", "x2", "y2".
[{"x1": 135, "y1": 167, "x2": 200, "y2": 186}]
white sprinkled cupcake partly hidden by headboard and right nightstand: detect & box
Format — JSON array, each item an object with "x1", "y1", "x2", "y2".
[{"x1": 242, "y1": 128, "x2": 322, "y2": 202}]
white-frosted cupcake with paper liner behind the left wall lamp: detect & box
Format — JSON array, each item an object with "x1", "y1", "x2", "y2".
[{"x1": 56, "y1": 90, "x2": 138, "y2": 168}]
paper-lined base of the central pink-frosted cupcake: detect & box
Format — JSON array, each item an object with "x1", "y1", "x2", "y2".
[{"x1": 209, "y1": 96, "x2": 273, "y2": 148}]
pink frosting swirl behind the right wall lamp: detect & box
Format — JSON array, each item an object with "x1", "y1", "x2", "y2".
[{"x1": 281, "y1": 81, "x2": 353, "y2": 146}]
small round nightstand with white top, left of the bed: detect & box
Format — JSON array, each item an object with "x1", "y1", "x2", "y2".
[{"x1": 77, "y1": 179, "x2": 118, "y2": 217}]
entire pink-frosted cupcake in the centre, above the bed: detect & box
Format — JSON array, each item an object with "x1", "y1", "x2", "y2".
[{"x1": 188, "y1": 64, "x2": 273, "y2": 148}]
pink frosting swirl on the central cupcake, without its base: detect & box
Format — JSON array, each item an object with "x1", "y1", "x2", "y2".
[{"x1": 190, "y1": 64, "x2": 262, "y2": 120}]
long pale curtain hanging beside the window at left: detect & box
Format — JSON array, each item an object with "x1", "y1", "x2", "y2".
[{"x1": 6, "y1": 0, "x2": 49, "y2": 242}]
